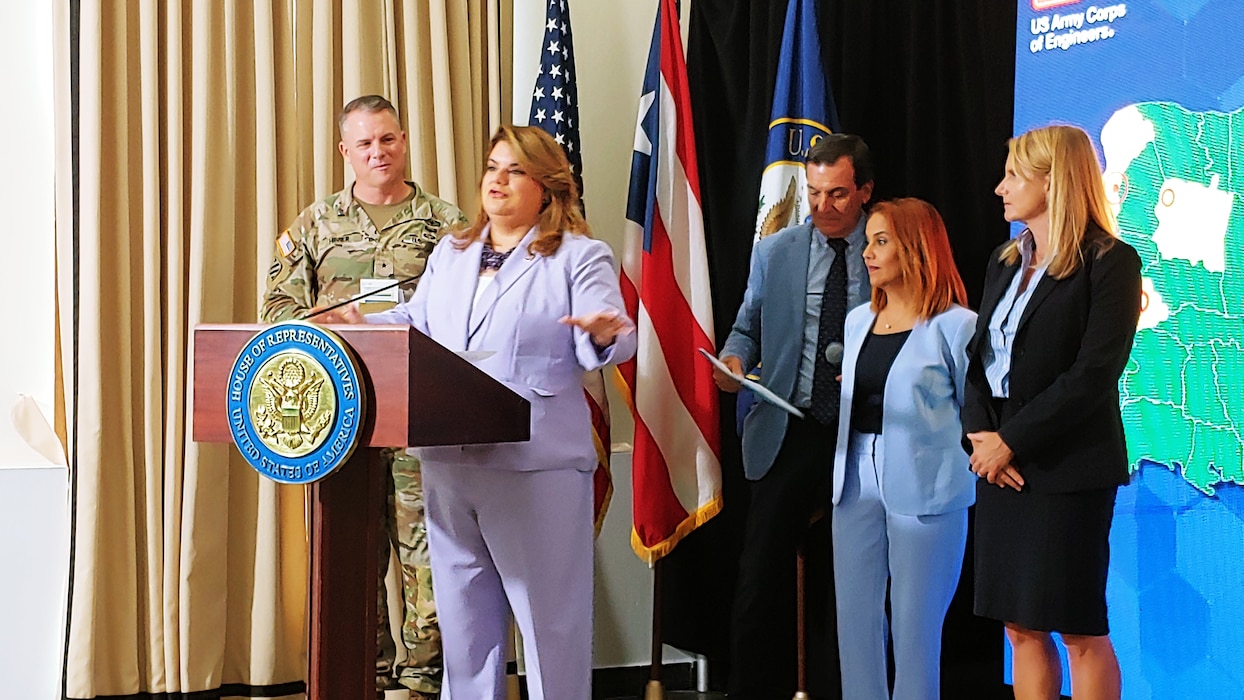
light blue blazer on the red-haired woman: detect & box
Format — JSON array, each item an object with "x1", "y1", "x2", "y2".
[{"x1": 833, "y1": 305, "x2": 977, "y2": 516}]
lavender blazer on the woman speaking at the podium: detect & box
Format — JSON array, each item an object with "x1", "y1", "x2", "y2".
[{"x1": 367, "y1": 229, "x2": 636, "y2": 471}]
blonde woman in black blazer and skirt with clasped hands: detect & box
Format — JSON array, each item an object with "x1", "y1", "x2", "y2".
[{"x1": 963, "y1": 126, "x2": 1141, "y2": 699}]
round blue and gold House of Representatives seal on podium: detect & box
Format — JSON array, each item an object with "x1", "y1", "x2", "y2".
[{"x1": 228, "y1": 321, "x2": 367, "y2": 484}]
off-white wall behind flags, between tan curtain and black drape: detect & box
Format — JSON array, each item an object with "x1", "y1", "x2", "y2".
[{"x1": 513, "y1": 0, "x2": 690, "y2": 668}]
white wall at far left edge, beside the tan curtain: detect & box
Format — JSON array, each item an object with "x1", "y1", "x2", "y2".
[{"x1": 0, "y1": 2, "x2": 68, "y2": 700}]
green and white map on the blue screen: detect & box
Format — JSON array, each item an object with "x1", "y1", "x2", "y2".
[{"x1": 1101, "y1": 102, "x2": 1244, "y2": 495}]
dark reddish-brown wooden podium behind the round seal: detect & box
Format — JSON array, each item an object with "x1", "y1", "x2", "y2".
[{"x1": 193, "y1": 325, "x2": 531, "y2": 700}]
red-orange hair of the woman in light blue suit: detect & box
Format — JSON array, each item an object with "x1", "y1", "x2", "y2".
[{"x1": 868, "y1": 196, "x2": 968, "y2": 321}]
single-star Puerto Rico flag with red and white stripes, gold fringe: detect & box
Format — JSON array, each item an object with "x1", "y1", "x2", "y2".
[{"x1": 621, "y1": 0, "x2": 722, "y2": 563}]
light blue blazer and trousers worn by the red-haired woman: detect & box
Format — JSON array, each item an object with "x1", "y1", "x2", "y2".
[{"x1": 832, "y1": 305, "x2": 977, "y2": 700}]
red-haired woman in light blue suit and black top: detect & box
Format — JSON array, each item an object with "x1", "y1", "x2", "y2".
[{"x1": 833, "y1": 199, "x2": 977, "y2": 700}]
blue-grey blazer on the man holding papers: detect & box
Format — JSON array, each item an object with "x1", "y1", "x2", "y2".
[{"x1": 720, "y1": 223, "x2": 870, "y2": 481}]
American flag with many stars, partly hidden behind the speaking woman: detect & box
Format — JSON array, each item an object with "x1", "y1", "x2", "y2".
[{"x1": 527, "y1": 0, "x2": 613, "y2": 535}]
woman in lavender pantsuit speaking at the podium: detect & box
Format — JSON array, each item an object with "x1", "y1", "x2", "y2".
[{"x1": 328, "y1": 127, "x2": 636, "y2": 700}]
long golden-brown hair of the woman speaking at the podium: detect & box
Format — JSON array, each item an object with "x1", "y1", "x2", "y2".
[{"x1": 453, "y1": 126, "x2": 592, "y2": 255}]
